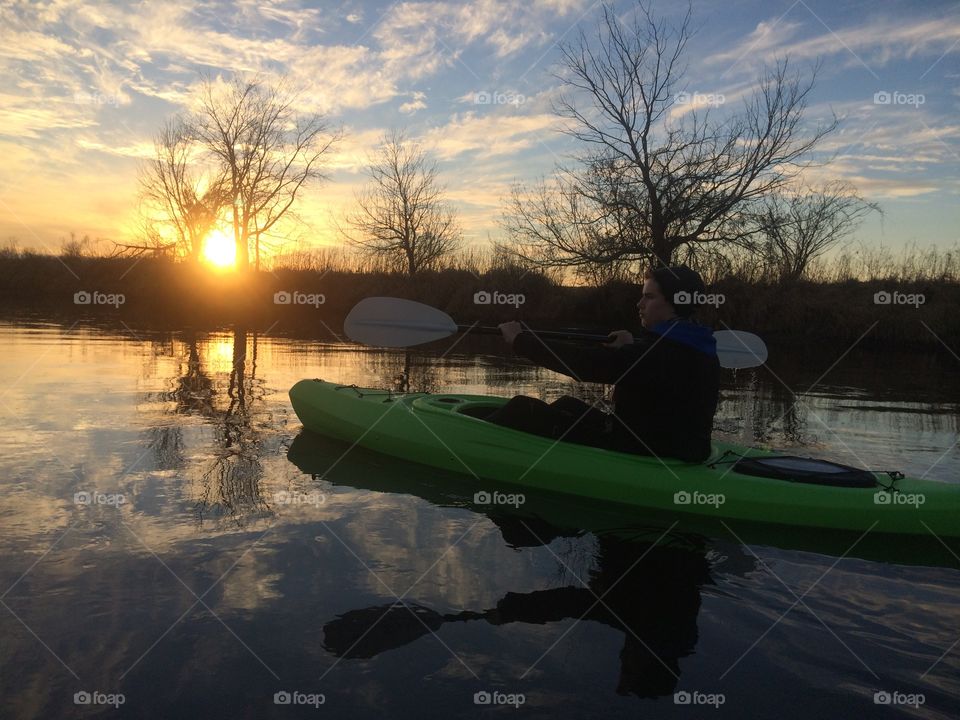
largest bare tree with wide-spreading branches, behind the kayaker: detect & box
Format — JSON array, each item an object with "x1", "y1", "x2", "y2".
[{"x1": 507, "y1": 2, "x2": 837, "y2": 266}]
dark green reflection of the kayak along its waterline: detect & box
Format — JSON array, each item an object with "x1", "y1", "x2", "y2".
[{"x1": 287, "y1": 429, "x2": 958, "y2": 575}]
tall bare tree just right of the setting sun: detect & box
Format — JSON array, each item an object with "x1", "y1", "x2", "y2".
[{"x1": 191, "y1": 79, "x2": 341, "y2": 269}]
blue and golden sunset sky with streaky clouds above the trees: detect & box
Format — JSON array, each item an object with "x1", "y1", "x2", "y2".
[{"x1": 0, "y1": 0, "x2": 960, "y2": 258}]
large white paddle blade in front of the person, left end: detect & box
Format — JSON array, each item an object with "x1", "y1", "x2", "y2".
[{"x1": 343, "y1": 298, "x2": 457, "y2": 347}]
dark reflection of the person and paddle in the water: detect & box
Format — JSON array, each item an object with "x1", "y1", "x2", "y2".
[{"x1": 323, "y1": 536, "x2": 710, "y2": 697}]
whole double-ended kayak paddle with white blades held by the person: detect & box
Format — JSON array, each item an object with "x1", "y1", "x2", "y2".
[{"x1": 343, "y1": 297, "x2": 767, "y2": 368}]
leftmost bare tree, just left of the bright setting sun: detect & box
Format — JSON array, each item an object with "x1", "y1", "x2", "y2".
[{"x1": 138, "y1": 117, "x2": 229, "y2": 261}]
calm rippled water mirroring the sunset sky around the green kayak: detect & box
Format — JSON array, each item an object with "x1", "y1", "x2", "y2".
[{"x1": 0, "y1": 321, "x2": 960, "y2": 718}]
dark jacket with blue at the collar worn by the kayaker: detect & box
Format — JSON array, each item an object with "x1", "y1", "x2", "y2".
[{"x1": 513, "y1": 320, "x2": 720, "y2": 462}]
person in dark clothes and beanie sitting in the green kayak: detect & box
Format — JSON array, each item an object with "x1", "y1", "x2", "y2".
[{"x1": 488, "y1": 265, "x2": 720, "y2": 462}]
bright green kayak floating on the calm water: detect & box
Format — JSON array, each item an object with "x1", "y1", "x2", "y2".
[{"x1": 290, "y1": 380, "x2": 960, "y2": 537}]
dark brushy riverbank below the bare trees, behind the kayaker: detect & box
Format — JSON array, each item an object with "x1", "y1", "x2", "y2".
[{"x1": 0, "y1": 246, "x2": 960, "y2": 354}]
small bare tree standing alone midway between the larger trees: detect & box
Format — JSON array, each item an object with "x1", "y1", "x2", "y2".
[{"x1": 347, "y1": 132, "x2": 461, "y2": 275}]
